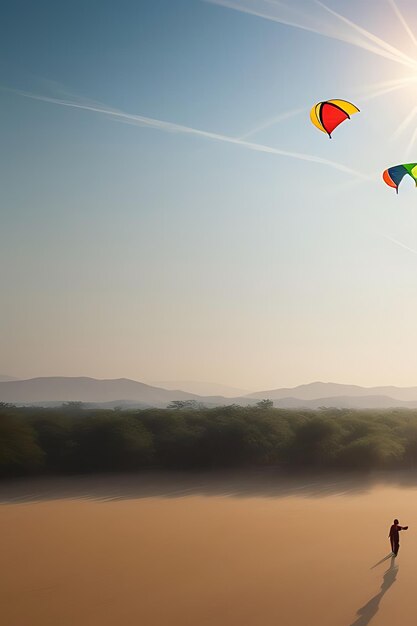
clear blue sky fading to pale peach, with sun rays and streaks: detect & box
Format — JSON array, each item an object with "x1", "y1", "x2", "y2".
[{"x1": 4, "y1": 0, "x2": 417, "y2": 391}]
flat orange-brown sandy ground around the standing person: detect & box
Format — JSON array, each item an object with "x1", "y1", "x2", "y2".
[{"x1": 0, "y1": 475, "x2": 417, "y2": 626}]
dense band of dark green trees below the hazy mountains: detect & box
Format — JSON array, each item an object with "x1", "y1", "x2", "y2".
[{"x1": 0, "y1": 400, "x2": 417, "y2": 478}]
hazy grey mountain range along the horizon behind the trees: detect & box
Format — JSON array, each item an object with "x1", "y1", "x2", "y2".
[{"x1": 4, "y1": 376, "x2": 417, "y2": 409}]
